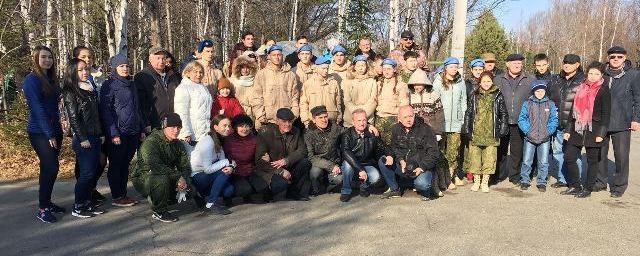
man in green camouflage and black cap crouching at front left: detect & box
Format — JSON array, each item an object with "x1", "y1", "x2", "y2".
[{"x1": 131, "y1": 113, "x2": 193, "y2": 222}]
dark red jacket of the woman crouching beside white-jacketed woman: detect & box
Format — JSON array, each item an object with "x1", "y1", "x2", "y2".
[{"x1": 223, "y1": 133, "x2": 258, "y2": 177}]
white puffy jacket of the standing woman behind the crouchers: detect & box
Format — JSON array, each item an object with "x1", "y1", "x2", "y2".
[{"x1": 173, "y1": 77, "x2": 213, "y2": 141}]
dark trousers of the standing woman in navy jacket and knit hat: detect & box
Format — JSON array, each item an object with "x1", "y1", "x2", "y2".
[{"x1": 107, "y1": 136, "x2": 140, "y2": 199}]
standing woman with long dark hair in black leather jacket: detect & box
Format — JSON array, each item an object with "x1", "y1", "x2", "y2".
[{"x1": 62, "y1": 59, "x2": 104, "y2": 218}]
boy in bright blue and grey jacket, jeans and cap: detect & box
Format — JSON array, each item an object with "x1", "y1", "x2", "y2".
[{"x1": 518, "y1": 80, "x2": 558, "y2": 192}]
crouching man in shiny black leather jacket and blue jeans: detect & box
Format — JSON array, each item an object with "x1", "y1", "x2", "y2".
[{"x1": 340, "y1": 109, "x2": 384, "y2": 202}]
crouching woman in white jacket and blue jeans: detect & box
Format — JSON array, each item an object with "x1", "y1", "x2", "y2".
[{"x1": 191, "y1": 115, "x2": 236, "y2": 215}]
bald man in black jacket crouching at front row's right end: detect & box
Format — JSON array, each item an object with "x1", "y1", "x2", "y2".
[{"x1": 379, "y1": 106, "x2": 438, "y2": 201}]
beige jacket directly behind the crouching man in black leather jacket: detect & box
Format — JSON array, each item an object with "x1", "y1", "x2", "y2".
[{"x1": 343, "y1": 75, "x2": 378, "y2": 127}]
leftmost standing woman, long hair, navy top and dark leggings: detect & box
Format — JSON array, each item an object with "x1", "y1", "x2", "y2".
[{"x1": 22, "y1": 46, "x2": 66, "y2": 223}]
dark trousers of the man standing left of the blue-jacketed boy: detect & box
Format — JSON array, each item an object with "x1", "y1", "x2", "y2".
[{"x1": 497, "y1": 124, "x2": 524, "y2": 183}]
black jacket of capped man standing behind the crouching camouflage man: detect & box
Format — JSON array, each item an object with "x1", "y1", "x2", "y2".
[{"x1": 133, "y1": 66, "x2": 180, "y2": 128}]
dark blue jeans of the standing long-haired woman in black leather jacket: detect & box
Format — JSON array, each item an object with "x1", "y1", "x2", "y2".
[{"x1": 71, "y1": 136, "x2": 102, "y2": 206}]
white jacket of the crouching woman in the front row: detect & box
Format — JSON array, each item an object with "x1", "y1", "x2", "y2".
[{"x1": 190, "y1": 135, "x2": 230, "y2": 177}]
